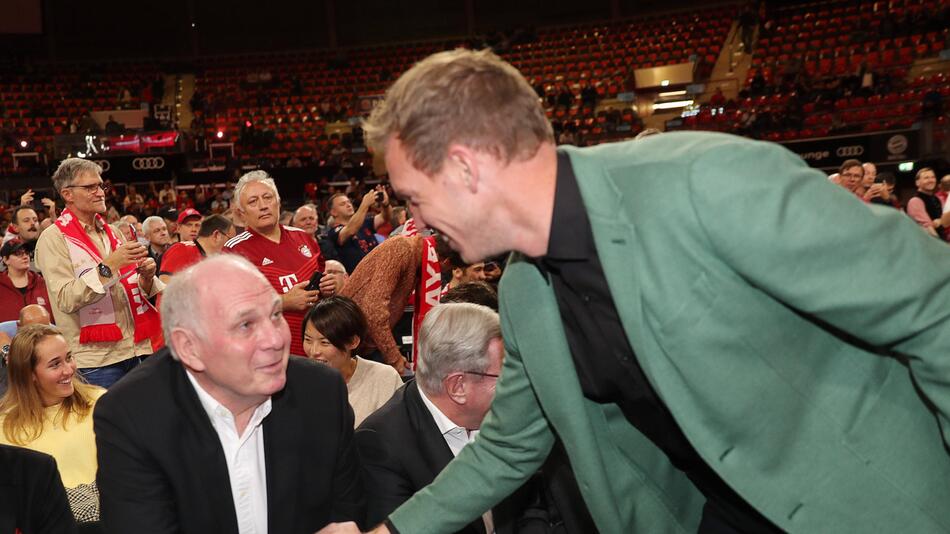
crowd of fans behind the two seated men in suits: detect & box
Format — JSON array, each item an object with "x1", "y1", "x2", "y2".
[{"x1": 0, "y1": 159, "x2": 536, "y2": 525}]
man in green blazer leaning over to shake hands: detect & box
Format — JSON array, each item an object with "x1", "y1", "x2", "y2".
[{"x1": 328, "y1": 47, "x2": 950, "y2": 534}]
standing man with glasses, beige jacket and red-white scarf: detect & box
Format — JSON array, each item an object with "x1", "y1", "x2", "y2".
[{"x1": 36, "y1": 158, "x2": 164, "y2": 388}]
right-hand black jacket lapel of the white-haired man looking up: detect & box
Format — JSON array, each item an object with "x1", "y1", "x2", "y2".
[{"x1": 263, "y1": 387, "x2": 300, "y2": 532}]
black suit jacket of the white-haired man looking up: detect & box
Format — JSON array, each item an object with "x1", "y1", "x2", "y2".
[{"x1": 93, "y1": 349, "x2": 363, "y2": 534}]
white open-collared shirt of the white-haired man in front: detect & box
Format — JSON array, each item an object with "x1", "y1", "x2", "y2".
[{"x1": 187, "y1": 372, "x2": 271, "y2": 534}]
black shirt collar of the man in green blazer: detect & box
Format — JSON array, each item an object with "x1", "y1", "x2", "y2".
[{"x1": 542, "y1": 151, "x2": 593, "y2": 260}]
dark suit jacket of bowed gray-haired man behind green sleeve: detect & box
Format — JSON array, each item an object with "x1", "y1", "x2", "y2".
[{"x1": 356, "y1": 380, "x2": 592, "y2": 534}]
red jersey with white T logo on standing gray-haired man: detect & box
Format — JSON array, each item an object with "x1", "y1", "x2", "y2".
[{"x1": 224, "y1": 225, "x2": 324, "y2": 356}]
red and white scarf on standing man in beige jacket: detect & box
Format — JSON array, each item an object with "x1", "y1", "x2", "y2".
[{"x1": 56, "y1": 208, "x2": 161, "y2": 344}]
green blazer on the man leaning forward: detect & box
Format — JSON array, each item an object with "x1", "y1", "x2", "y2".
[{"x1": 390, "y1": 133, "x2": 950, "y2": 534}]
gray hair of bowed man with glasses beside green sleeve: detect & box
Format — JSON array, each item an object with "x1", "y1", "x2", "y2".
[{"x1": 416, "y1": 303, "x2": 501, "y2": 393}]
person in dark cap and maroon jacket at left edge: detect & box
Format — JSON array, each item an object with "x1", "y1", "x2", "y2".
[{"x1": 0, "y1": 242, "x2": 53, "y2": 321}]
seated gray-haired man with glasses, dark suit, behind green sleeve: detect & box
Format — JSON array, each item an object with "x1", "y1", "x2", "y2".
[{"x1": 356, "y1": 303, "x2": 593, "y2": 534}]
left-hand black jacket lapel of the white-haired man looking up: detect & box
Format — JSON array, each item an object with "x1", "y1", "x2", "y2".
[{"x1": 170, "y1": 362, "x2": 237, "y2": 532}]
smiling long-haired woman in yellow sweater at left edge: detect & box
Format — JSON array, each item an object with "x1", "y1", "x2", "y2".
[{"x1": 0, "y1": 325, "x2": 105, "y2": 522}]
